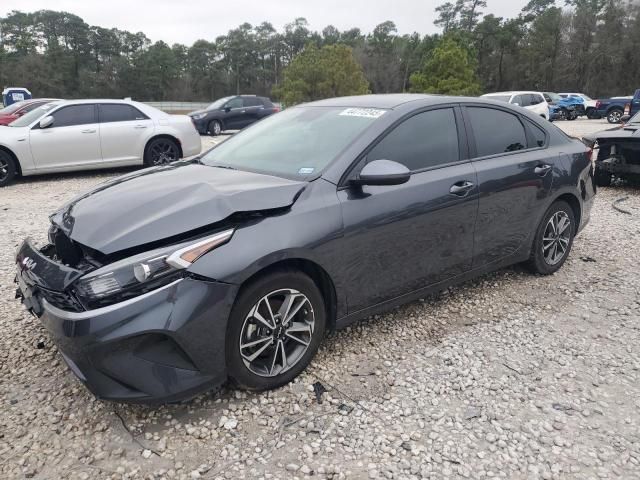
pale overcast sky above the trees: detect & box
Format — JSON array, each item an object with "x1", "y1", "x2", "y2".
[{"x1": 0, "y1": 0, "x2": 527, "y2": 45}]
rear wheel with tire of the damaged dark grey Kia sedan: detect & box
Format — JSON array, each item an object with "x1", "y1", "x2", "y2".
[{"x1": 528, "y1": 200, "x2": 577, "y2": 275}]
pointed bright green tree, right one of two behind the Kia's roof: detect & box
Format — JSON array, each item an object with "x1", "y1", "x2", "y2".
[{"x1": 410, "y1": 37, "x2": 480, "y2": 95}]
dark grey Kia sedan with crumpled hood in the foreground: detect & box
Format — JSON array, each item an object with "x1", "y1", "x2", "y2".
[{"x1": 16, "y1": 94, "x2": 595, "y2": 402}]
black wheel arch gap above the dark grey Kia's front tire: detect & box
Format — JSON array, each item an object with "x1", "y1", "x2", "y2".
[{"x1": 232, "y1": 258, "x2": 338, "y2": 330}]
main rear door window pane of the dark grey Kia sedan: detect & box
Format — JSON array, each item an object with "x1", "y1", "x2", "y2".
[{"x1": 467, "y1": 107, "x2": 527, "y2": 157}]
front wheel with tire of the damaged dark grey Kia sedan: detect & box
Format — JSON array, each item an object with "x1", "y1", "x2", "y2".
[{"x1": 226, "y1": 270, "x2": 326, "y2": 390}]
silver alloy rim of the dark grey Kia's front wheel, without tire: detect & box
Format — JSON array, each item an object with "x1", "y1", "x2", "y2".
[{"x1": 239, "y1": 289, "x2": 315, "y2": 377}]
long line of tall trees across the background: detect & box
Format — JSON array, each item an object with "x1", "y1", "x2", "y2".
[{"x1": 0, "y1": 0, "x2": 640, "y2": 103}]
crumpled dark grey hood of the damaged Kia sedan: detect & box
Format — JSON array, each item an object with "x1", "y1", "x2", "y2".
[{"x1": 51, "y1": 163, "x2": 306, "y2": 255}]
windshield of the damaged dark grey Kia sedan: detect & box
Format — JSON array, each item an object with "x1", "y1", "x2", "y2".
[{"x1": 200, "y1": 107, "x2": 386, "y2": 178}]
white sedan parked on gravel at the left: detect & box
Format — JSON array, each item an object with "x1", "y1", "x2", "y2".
[{"x1": 0, "y1": 100, "x2": 201, "y2": 187}]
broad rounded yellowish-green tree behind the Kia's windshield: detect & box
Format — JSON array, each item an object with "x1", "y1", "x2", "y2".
[{"x1": 276, "y1": 43, "x2": 369, "y2": 105}]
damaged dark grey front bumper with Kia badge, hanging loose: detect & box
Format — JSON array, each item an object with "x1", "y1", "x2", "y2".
[{"x1": 16, "y1": 240, "x2": 237, "y2": 403}]
